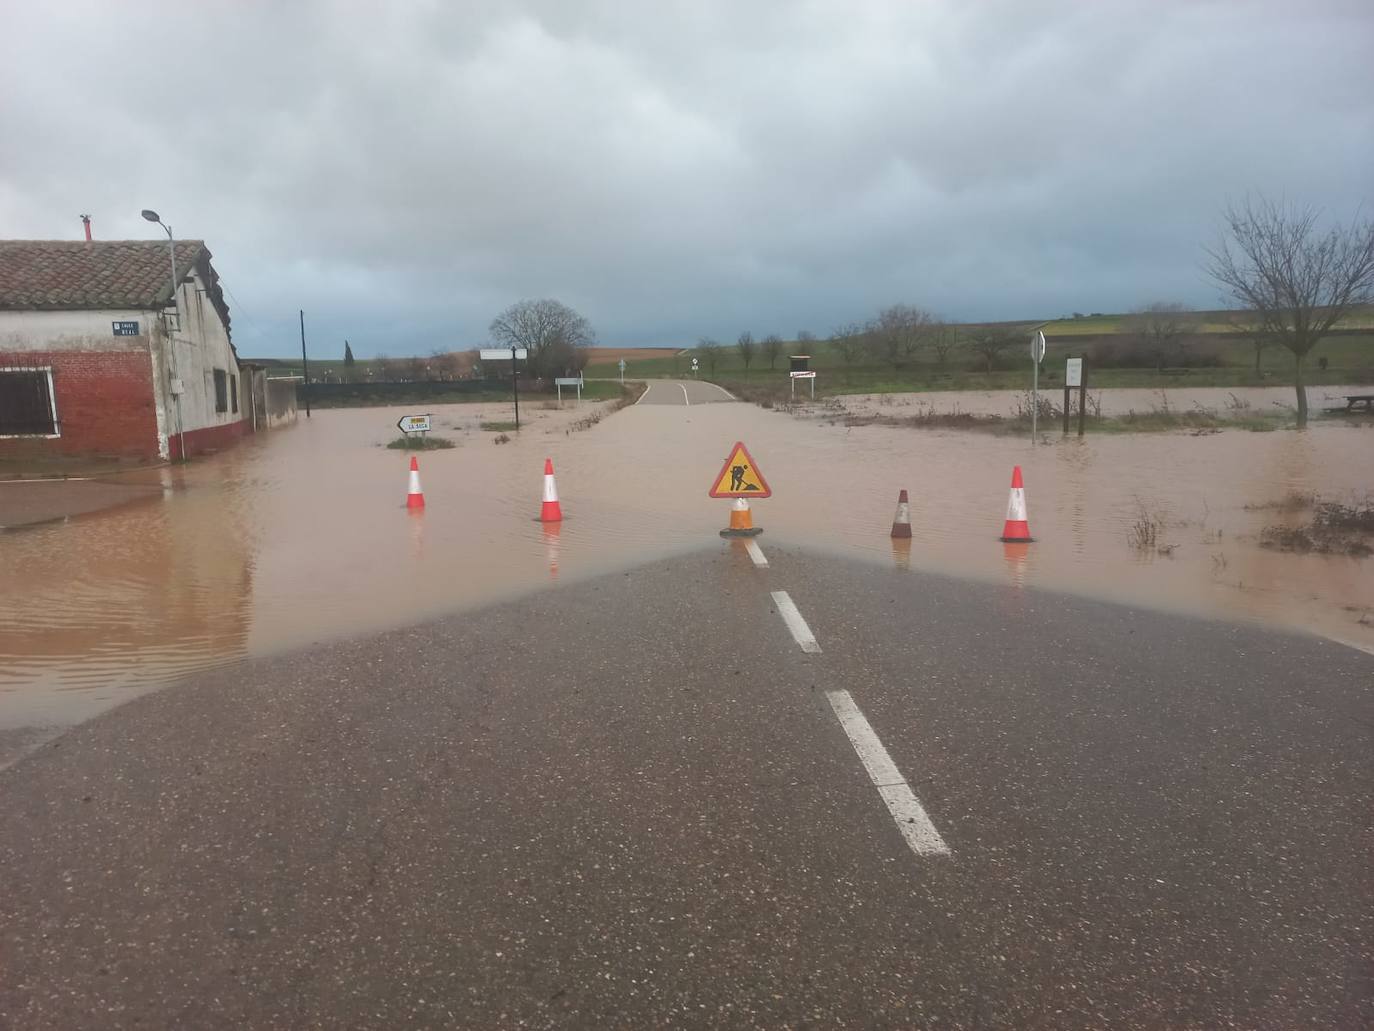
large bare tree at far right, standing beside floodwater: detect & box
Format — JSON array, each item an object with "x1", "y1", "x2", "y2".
[{"x1": 1205, "y1": 197, "x2": 1374, "y2": 426}]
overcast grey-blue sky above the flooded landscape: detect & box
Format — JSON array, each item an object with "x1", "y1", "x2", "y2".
[{"x1": 0, "y1": 0, "x2": 1374, "y2": 357}]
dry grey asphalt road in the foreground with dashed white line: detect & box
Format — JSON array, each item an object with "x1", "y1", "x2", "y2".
[{"x1": 0, "y1": 544, "x2": 1374, "y2": 1028}]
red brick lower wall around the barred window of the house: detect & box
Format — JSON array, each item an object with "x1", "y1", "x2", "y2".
[{"x1": 0, "y1": 351, "x2": 158, "y2": 459}]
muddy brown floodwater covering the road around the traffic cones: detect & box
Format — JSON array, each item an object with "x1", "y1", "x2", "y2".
[{"x1": 0, "y1": 392, "x2": 1374, "y2": 757}]
